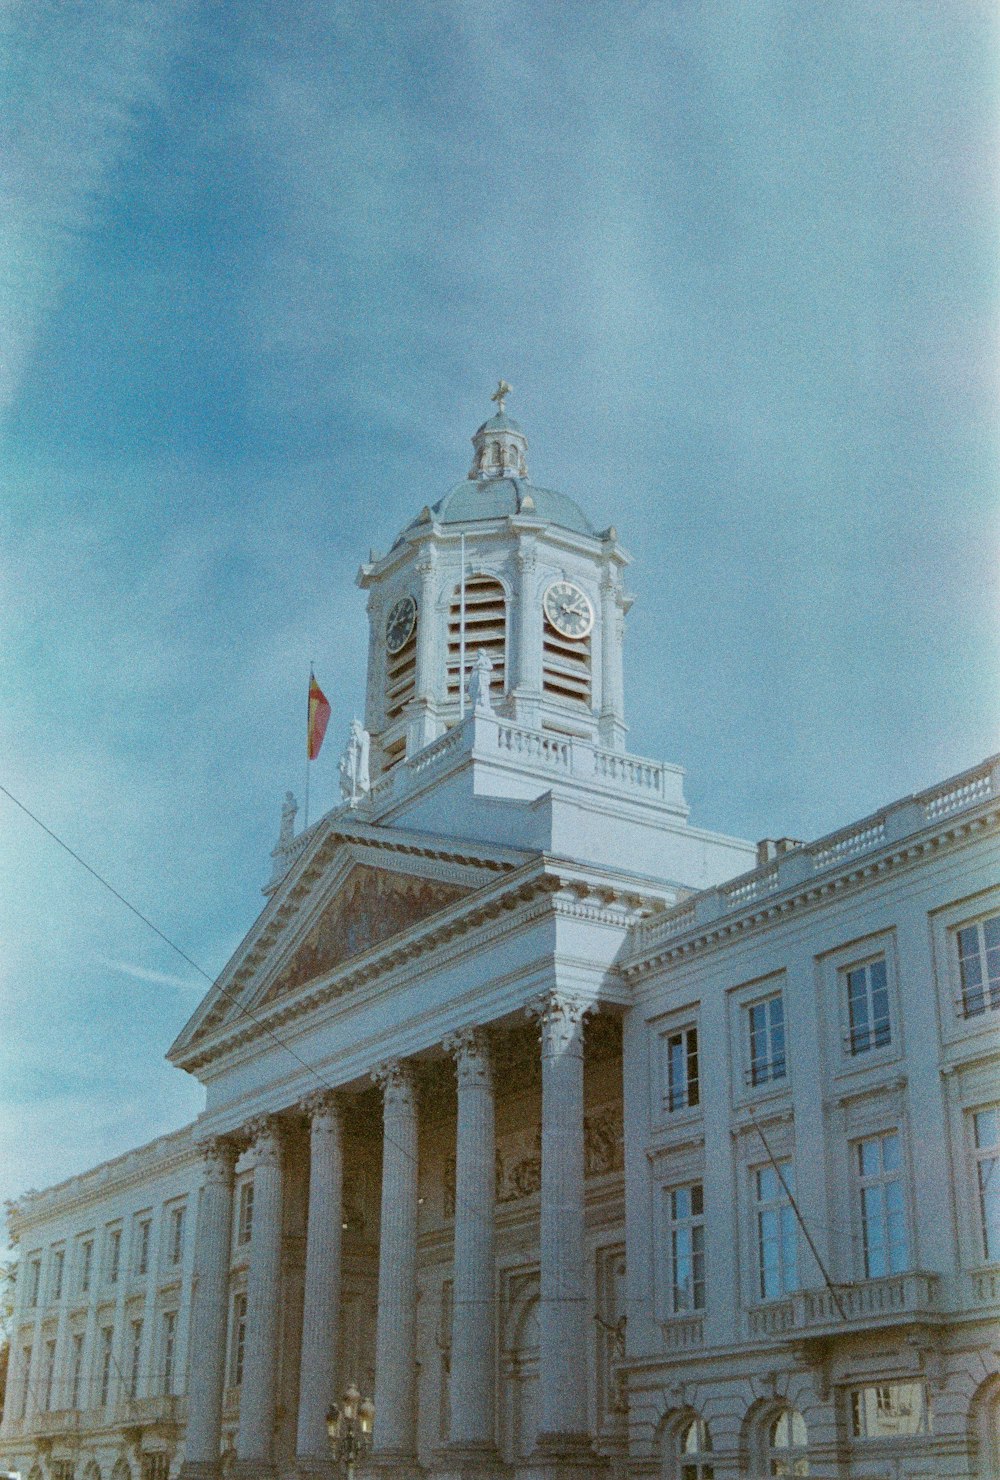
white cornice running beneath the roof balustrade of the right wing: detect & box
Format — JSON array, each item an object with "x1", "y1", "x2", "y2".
[{"x1": 620, "y1": 801, "x2": 1000, "y2": 981}]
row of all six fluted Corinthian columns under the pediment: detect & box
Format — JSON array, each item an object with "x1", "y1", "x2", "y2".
[{"x1": 185, "y1": 993, "x2": 590, "y2": 1480}]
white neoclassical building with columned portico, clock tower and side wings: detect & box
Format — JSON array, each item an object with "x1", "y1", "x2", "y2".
[{"x1": 0, "y1": 399, "x2": 1000, "y2": 1480}]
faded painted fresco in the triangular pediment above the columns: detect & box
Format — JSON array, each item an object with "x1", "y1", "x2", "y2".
[{"x1": 265, "y1": 867, "x2": 469, "y2": 1002}]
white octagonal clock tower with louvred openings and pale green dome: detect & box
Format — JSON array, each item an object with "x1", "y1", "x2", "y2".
[{"x1": 358, "y1": 380, "x2": 630, "y2": 776}]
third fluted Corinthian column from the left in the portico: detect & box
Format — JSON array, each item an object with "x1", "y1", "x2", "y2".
[{"x1": 296, "y1": 1092, "x2": 343, "y2": 1470}]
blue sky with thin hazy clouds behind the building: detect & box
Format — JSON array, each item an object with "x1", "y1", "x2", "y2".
[{"x1": 0, "y1": 0, "x2": 1000, "y2": 1213}]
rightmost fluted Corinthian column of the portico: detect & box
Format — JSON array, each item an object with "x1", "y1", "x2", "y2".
[{"x1": 537, "y1": 992, "x2": 589, "y2": 1452}]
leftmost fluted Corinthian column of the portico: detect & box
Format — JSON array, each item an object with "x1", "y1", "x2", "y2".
[{"x1": 179, "y1": 1138, "x2": 238, "y2": 1480}]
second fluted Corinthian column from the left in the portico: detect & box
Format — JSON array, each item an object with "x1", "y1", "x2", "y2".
[{"x1": 237, "y1": 1116, "x2": 283, "y2": 1480}]
